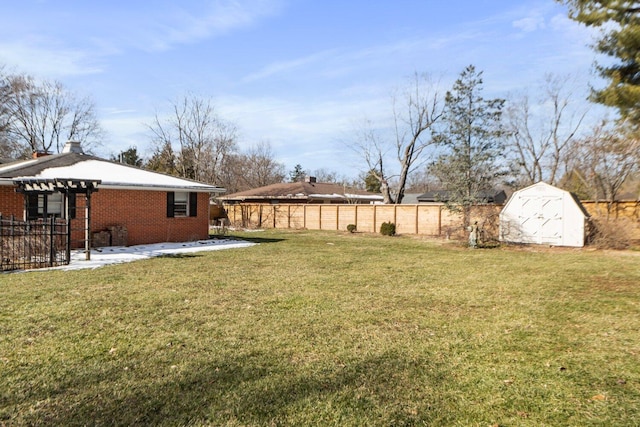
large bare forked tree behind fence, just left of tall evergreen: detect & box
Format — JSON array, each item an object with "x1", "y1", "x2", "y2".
[{"x1": 351, "y1": 73, "x2": 443, "y2": 203}]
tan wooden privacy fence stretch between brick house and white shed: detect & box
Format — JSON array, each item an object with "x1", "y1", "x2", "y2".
[{"x1": 225, "y1": 204, "x2": 502, "y2": 238}]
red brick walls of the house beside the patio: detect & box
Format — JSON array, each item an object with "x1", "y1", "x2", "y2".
[{"x1": 0, "y1": 186, "x2": 209, "y2": 247}]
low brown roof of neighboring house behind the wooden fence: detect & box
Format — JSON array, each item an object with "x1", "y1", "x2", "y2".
[{"x1": 219, "y1": 180, "x2": 383, "y2": 203}]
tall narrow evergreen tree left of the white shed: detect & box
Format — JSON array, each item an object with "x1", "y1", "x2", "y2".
[{"x1": 431, "y1": 65, "x2": 506, "y2": 227}]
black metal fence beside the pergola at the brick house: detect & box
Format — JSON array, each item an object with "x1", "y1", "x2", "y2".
[{"x1": 0, "y1": 216, "x2": 70, "y2": 271}]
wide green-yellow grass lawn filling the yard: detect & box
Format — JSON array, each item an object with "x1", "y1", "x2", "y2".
[{"x1": 0, "y1": 231, "x2": 640, "y2": 427}]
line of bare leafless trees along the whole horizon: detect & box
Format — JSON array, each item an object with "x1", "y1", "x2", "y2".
[{"x1": 0, "y1": 61, "x2": 640, "y2": 203}]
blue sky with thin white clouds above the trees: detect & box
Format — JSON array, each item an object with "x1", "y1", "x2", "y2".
[{"x1": 0, "y1": 0, "x2": 595, "y2": 177}]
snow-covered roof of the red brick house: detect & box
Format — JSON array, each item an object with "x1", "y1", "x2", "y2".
[{"x1": 0, "y1": 147, "x2": 225, "y2": 193}]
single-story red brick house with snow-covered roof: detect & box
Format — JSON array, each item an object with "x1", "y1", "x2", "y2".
[{"x1": 0, "y1": 142, "x2": 225, "y2": 247}]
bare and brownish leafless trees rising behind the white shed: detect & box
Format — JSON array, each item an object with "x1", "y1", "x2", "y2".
[{"x1": 507, "y1": 75, "x2": 640, "y2": 205}]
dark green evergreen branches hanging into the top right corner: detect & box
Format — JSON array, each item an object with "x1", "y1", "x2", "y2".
[{"x1": 557, "y1": 0, "x2": 640, "y2": 129}]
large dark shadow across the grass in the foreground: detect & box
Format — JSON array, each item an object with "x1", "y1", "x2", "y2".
[{"x1": 13, "y1": 353, "x2": 446, "y2": 426}]
